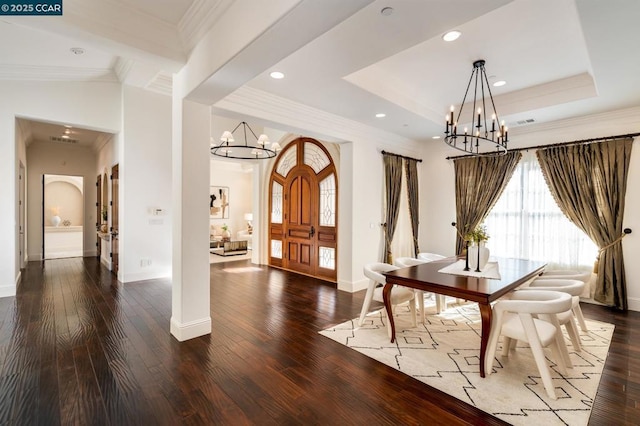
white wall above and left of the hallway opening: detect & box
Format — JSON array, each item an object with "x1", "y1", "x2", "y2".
[{"x1": 0, "y1": 81, "x2": 120, "y2": 296}]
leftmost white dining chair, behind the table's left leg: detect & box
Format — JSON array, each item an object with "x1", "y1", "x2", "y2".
[{"x1": 358, "y1": 262, "x2": 416, "y2": 337}]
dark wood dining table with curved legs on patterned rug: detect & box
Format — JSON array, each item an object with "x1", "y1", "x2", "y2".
[{"x1": 382, "y1": 257, "x2": 546, "y2": 377}]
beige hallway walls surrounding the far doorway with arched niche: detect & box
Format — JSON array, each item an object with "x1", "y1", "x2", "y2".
[{"x1": 27, "y1": 141, "x2": 96, "y2": 261}]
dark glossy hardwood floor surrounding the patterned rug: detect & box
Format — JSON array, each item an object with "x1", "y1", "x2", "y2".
[{"x1": 0, "y1": 258, "x2": 640, "y2": 425}]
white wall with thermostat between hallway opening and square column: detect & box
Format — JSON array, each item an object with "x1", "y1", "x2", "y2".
[{"x1": 118, "y1": 86, "x2": 172, "y2": 283}]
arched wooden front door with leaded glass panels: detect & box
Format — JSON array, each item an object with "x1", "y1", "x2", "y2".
[{"x1": 269, "y1": 138, "x2": 338, "y2": 282}]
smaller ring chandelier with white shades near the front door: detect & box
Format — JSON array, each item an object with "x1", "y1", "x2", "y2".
[{"x1": 211, "y1": 121, "x2": 280, "y2": 160}]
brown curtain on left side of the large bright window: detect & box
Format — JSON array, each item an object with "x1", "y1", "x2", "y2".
[{"x1": 454, "y1": 152, "x2": 522, "y2": 254}]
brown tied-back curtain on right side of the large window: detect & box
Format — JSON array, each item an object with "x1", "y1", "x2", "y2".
[{"x1": 536, "y1": 138, "x2": 633, "y2": 310}]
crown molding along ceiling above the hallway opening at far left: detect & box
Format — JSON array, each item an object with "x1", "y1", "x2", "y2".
[{"x1": 0, "y1": 65, "x2": 119, "y2": 83}]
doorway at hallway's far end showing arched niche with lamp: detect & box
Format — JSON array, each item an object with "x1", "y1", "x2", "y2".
[{"x1": 42, "y1": 174, "x2": 84, "y2": 259}]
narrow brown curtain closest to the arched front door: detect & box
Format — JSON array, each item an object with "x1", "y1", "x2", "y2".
[{"x1": 382, "y1": 154, "x2": 402, "y2": 264}]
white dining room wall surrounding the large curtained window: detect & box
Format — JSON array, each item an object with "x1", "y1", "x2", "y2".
[{"x1": 420, "y1": 108, "x2": 640, "y2": 311}]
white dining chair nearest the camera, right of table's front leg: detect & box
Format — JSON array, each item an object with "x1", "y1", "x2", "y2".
[{"x1": 485, "y1": 290, "x2": 571, "y2": 399}]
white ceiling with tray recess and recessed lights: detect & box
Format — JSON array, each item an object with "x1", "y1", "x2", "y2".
[{"x1": 5, "y1": 0, "x2": 640, "y2": 146}]
